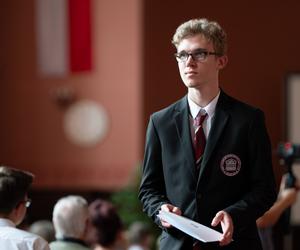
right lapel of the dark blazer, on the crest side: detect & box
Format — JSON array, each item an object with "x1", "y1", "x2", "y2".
[{"x1": 199, "y1": 91, "x2": 229, "y2": 179}]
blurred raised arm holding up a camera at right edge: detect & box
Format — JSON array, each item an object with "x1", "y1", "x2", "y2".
[{"x1": 256, "y1": 175, "x2": 300, "y2": 250}]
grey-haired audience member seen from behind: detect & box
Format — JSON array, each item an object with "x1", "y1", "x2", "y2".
[{"x1": 50, "y1": 195, "x2": 90, "y2": 250}]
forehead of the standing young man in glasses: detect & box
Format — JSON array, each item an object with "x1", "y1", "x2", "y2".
[{"x1": 177, "y1": 34, "x2": 214, "y2": 51}]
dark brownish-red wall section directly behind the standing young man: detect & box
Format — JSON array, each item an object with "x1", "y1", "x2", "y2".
[{"x1": 143, "y1": 0, "x2": 300, "y2": 180}]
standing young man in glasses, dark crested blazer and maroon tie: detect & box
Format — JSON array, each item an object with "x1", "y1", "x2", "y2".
[{"x1": 139, "y1": 18, "x2": 276, "y2": 250}]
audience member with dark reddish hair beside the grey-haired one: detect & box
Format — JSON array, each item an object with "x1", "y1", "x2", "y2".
[{"x1": 87, "y1": 199, "x2": 126, "y2": 250}]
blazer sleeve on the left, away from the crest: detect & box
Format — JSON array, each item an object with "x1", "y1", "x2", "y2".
[{"x1": 139, "y1": 116, "x2": 169, "y2": 226}]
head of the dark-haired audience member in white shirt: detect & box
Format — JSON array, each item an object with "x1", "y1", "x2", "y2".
[{"x1": 0, "y1": 166, "x2": 34, "y2": 224}]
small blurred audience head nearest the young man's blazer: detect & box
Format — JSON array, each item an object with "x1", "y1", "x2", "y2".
[{"x1": 127, "y1": 221, "x2": 153, "y2": 250}]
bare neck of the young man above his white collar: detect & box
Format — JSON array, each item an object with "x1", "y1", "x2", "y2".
[{"x1": 188, "y1": 86, "x2": 220, "y2": 107}]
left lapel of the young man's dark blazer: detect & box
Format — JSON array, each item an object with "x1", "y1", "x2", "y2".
[{"x1": 174, "y1": 96, "x2": 196, "y2": 178}]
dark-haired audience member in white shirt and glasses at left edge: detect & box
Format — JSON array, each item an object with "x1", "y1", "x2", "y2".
[{"x1": 0, "y1": 166, "x2": 49, "y2": 250}]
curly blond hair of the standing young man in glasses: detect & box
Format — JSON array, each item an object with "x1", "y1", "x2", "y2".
[{"x1": 172, "y1": 18, "x2": 227, "y2": 55}]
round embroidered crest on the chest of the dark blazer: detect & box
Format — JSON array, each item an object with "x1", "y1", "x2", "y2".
[{"x1": 220, "y1": 154, "x2": 242, "y2": 176}]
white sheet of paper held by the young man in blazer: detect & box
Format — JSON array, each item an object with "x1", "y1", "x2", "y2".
[{"x1": 158, "y1": 211, "x2": 222, "y2": 242}]
